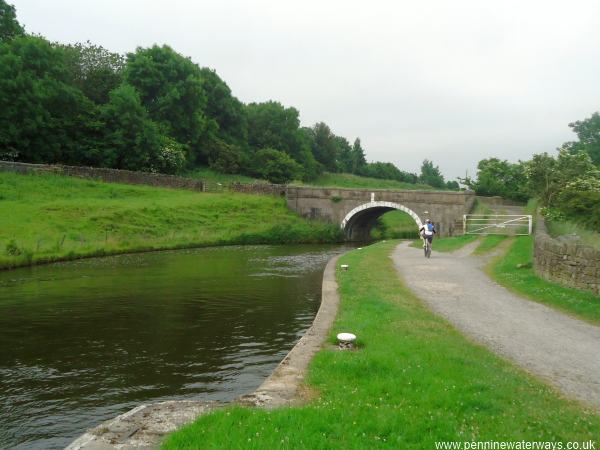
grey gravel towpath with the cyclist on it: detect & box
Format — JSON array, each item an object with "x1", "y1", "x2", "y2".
[{"x1": 392, "y1": 242, "x2": 600, "y2": 411}]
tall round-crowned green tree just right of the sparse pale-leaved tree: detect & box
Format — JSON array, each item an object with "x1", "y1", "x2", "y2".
[{"x1": 125, "y1": 45, "x2": 209, "y2": 162}]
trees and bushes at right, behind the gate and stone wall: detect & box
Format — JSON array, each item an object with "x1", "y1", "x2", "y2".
[{"x1": 463, "y1": 112, "x2": 600, "y2": 230}]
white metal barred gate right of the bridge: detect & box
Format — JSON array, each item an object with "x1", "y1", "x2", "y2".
[{"x1": 463, "y1": 214, "x2": 532, "y2": 236}]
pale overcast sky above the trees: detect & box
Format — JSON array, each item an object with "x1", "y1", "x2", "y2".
[{"x1": 8, "y1": 0, "x2": 600, "y2": 179}]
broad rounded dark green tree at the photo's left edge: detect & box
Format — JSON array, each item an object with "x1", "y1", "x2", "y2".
[{"x1": 0, "y1": 36, "x2": 101, "y2": 164}]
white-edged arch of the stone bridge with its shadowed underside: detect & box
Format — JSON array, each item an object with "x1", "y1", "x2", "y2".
[{"x1": 340, "y1": 202, "x2": 423, "y2": 241}]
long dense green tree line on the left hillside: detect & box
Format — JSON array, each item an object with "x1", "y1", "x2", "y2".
[{"x1": 0, "y1": 0, "x2": 458, "y2": 188}]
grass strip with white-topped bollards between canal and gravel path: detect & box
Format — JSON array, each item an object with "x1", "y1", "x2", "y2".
[{"x1": 163, "y1": 242, "x2": 600, "y2": 449}]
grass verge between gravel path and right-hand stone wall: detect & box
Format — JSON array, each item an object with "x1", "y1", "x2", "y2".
[{"x1": 488, "y1": 236, "x2": 600, "y2": 325}]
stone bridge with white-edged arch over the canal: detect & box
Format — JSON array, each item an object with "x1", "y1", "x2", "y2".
[{"x1": 285, "y1": 187, "x2": 475, "y2": 241}]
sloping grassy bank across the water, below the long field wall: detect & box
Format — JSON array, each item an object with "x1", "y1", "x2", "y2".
[{"x1": 0, "y1": 173, "x2": 343, "y2": 268}]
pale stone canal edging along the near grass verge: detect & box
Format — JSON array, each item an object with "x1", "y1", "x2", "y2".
[{"x1": 66, "y1": 255, "x2": 341, "y2": 450}]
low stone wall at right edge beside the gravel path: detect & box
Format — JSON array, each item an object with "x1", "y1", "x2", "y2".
[{"x1": 533, "y1": 217, "x2": 600, "y2": 295}]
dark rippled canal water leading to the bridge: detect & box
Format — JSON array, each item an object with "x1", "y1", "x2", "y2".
[{"x1": 0, "y1": 246, "x2": 346, "y2": 449}]
